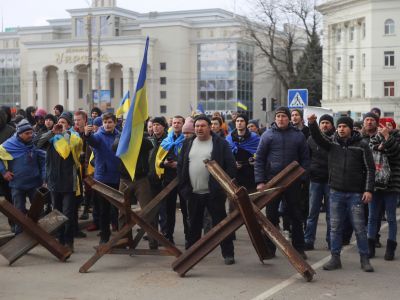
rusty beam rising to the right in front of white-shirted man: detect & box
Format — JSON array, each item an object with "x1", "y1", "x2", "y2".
[{"x1": 172, "y1": 162, "x2": 305, "y2": 276}]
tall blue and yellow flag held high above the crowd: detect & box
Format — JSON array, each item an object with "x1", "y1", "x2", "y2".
[{"x1": 117, "y1": 37, "x2": 149, "y2": 180}]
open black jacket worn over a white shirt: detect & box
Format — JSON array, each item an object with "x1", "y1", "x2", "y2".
[{"x1": 178, "y1": 133, "x2": 236, "y2": 199}]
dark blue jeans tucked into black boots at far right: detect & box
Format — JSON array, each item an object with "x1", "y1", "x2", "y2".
[{"x1": 368, "y1": 191, "x2": 398, "y2": 241}]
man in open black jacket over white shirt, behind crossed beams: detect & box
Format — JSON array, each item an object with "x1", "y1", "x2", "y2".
[{"x1": 178, "y1": 115, "x2": 236, "y2": 265}]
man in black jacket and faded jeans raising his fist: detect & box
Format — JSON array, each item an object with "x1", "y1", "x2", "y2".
[{"x1": 308, "y1": 114, "x2": 375, "y2": 272}]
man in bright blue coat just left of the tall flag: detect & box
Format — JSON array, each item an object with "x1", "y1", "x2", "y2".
[{"x1": 85, "y1": 113, "x2": 120, "y2": 244}]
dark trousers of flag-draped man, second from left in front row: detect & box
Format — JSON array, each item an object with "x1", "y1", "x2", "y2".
[{"x1": 51, "y1": 192, "x2": 75, "y2": 245}]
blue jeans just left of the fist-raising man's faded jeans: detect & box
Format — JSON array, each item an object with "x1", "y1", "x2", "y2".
[{"x1": 304, "y1": 181, "x2": 331, "y2": 245}]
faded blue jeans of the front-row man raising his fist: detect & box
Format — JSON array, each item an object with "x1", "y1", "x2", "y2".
[{"x1": 329, "y1": 189, "x2": 368, "y2": 255}]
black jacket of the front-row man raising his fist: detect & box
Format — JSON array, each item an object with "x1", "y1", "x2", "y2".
[{"x1": 309, "y1": 123, "x2": 375, "y2": 193}]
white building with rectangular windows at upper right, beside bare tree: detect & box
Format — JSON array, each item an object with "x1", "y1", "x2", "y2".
[{"x1": 317, "y1": 0, "x2": 400, "y2": 120}]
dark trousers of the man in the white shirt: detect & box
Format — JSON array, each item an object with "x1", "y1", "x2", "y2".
[{"x1": 187, "y1": 193, "x2": 234, "y2": 257}]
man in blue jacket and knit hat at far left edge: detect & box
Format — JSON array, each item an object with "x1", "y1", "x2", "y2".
[{"x1": 0, "y1": 119, "x2": 46, "y2": 234}]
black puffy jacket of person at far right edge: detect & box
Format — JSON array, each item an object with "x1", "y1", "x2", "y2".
[{"x1": 369, "y1": 130, "x2": 400, "y2": 192}]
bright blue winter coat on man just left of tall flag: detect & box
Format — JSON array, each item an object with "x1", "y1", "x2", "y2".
[{"x1": 85, "y1": 127, "x2": 120, "y2": 184}]
